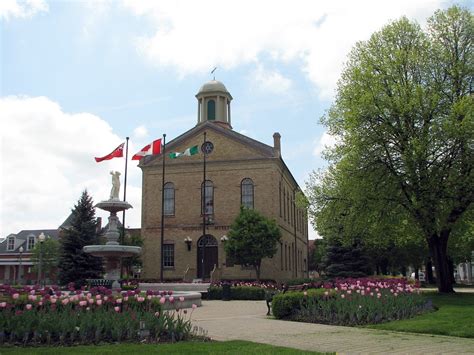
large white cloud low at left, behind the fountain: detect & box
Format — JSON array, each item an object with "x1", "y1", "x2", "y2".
[{"x1": 0, "y1": 96, "x2": 141, "y2": 237}]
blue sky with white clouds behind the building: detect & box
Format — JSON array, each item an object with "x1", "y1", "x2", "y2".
[{"x1": 0, "y1": 0, "x2": 460, "y2": 238}]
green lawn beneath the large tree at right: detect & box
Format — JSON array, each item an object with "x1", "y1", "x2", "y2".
[{"x1": 368, "y1": 292, "x2": 474, "y2": 338}]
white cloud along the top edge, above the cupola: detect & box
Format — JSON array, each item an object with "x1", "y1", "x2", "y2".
[{"x1": 123, "y1": 0, "x2": 443, "y2": 99}]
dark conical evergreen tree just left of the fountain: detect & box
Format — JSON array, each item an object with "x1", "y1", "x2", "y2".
[{"x1": 58, "y1": 191, "x2": 103, "y2": 286}]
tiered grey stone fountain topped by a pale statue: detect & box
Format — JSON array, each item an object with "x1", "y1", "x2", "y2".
[{"x1": 83, "y1": 171, "x2": 142, "y2": 289}]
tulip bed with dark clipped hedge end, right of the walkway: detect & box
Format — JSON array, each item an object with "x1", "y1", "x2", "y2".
[{"x1": 272, "y1": 279, "x2": 430, "y2": 326}]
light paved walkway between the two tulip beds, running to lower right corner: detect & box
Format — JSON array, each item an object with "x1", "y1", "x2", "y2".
[{"x1": 192, "y1": 301, "x2": 474, "y2": 354}]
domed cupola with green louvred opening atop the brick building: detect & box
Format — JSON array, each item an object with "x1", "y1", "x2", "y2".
[{"x1": 196, "y1": 80, "x2": 232, "y2": 128}]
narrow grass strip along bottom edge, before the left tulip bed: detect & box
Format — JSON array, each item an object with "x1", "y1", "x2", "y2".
[{"x1": 0, "y1": 340, "x2": 326, "y2": 355}]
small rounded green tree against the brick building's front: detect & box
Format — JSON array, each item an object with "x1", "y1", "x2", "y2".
[{"x1": 225, "y1": 207, "x2": 281, "y2": 281}]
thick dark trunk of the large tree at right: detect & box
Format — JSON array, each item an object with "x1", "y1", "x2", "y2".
[{"x1": 428, "y1": 231, "x2": 454, "y2": 293}]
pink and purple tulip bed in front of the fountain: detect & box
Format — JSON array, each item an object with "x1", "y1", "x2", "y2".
[{"x1": 0, "y1": 287, "x2": 199, "y2": 345}]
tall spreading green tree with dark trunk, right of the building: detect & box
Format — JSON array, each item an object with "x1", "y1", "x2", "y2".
[{"x1": 310, "y1": 7, "x2": 474, "y2": 292}]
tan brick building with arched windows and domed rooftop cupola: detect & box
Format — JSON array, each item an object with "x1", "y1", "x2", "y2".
[{"x1": 139, "y1": 80, "x2": 308, "y2": 281}]
